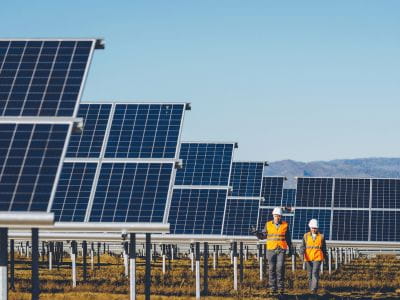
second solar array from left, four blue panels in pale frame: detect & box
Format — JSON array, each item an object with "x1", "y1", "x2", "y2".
[{"x1": 52, "y1": 103, "x2": 188, "y2": 222}]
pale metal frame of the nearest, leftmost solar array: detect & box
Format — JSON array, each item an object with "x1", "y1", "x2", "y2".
[{"x1": 0, "y1": 38, "x2": 100, "y2": 212}]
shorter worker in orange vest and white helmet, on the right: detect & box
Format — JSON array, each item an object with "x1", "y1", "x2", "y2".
[{"x1": 300, "y1": 219, "x2": 328, "y2": 293}]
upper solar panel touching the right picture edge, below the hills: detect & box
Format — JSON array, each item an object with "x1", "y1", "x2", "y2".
[{"x1": 372, "y1": 179, "x2": 400, "y2": 208}]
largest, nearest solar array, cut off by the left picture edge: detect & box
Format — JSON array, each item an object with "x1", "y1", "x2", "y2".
[{"x1": 0, "y1": 39, "x2": 97, "y2": 211}]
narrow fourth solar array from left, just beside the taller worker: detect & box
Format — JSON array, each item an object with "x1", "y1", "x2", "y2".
[{"x1": 223, "y1": 162, "x2": 265, "y2": 236}]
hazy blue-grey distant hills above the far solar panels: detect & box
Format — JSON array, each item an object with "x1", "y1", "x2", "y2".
[{"x1": 265, "y1": 158, "x2": 400, "y2": 187}]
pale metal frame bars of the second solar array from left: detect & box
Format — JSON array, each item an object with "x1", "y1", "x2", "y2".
[{"x1": 50, "y1": 100, "x2": 191, "y2": 223}]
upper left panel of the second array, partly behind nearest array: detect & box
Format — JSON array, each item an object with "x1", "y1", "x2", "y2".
[{"x1": 66, "y1": 104, "x2": 111, "y2": 158}]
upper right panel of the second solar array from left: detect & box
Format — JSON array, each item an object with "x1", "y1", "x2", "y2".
[{"x1": 105, "y1": 104, "x2": 185, "y2": 158}]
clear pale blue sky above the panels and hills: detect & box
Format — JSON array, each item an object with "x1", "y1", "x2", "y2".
[{"x1": 0, "y1": 0, "x2": 400, "y2": 161}]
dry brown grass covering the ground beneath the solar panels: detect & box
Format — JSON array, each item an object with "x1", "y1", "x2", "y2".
[{"x1": 10, "y1": 255, "x2": 400, "y2": 300}]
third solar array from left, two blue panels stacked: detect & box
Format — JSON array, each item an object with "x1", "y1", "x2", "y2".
[{"x1": 168, "y1": 143, "x2": 236, "y2": 234}]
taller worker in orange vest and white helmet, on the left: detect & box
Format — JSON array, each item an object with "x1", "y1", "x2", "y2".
[{"x1": 265, "y1": 207, "x2": 292, "y2": 294}]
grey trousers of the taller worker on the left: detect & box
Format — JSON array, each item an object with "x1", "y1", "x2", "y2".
[{"x1": 267, "y1": 249, "x2": 285, "y2": 290}]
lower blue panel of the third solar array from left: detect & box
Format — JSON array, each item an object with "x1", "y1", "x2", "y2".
[{"x1": 168, "y1": 189, "x2": 227, "y2": 235}]
